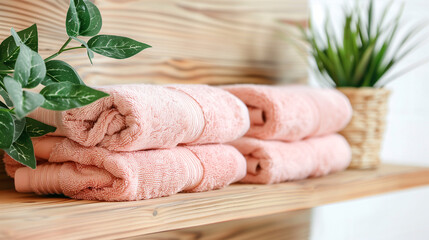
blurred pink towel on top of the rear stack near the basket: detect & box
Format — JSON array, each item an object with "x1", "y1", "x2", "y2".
[{"x1": 223, "y1": 85, "x2": 352, "y2": 141}]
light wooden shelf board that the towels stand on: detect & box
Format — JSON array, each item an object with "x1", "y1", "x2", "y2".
[{"x1": 0, "y1": 165, "x2": 429, "y2": 239}]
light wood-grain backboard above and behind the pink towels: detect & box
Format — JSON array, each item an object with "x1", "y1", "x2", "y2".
[{"x1": 0, "y1": 0, "x2": 307, "y2": 85}]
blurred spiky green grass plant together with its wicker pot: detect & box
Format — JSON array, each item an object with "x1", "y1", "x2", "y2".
[{"x1": 303, "y1": 1, "x2": 422, "y2": 169}]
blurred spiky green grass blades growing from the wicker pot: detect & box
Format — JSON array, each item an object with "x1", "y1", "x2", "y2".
[{"x1": 303, "y1": 1, "x2": 422, "y2": 87}]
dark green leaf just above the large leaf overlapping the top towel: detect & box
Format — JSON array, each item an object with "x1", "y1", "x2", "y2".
[{"x1": 42, "y1": 60, "x2": 85, "y2": 86}]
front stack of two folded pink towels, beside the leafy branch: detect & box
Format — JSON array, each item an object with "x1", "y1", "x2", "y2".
[{"x1": 4, "y1": 85, "x2": 250, "y2": 201}]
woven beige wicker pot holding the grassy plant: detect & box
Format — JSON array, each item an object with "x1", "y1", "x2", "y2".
[{"x1": 338, "y1": 88, "x2": 390, "y2": 169}]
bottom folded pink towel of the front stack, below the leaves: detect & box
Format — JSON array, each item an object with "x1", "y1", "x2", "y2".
[{"x1": 4, "y1": 137, "x2": 246, "y2": 201}]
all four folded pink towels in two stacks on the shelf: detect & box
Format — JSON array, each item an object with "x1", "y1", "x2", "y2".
[{"x1": 4, "y1": 85, "x2": 352, "y2": 201}]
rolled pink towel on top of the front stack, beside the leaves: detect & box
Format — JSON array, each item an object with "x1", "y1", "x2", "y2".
[{"x1": 29, "y1": 84, "x2": 250, "y2": 151}]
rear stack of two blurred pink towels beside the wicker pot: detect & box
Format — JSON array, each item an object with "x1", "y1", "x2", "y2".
[{"x1": 223, "y1": 85, "x2": 352, "y2": 184}]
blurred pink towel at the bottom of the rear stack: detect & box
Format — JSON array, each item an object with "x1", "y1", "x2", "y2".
[{"x1": 231, "y1": 134, "x2": 351, "y2": 184}]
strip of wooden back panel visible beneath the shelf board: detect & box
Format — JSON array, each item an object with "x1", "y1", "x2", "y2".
[{"x1": 132, "y1": 210, "x2": 311, "y2": 240}]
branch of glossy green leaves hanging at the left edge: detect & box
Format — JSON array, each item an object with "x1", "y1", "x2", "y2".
[{"x1": 0, "y1": 0, "x2": 150, "y2": 168}]
